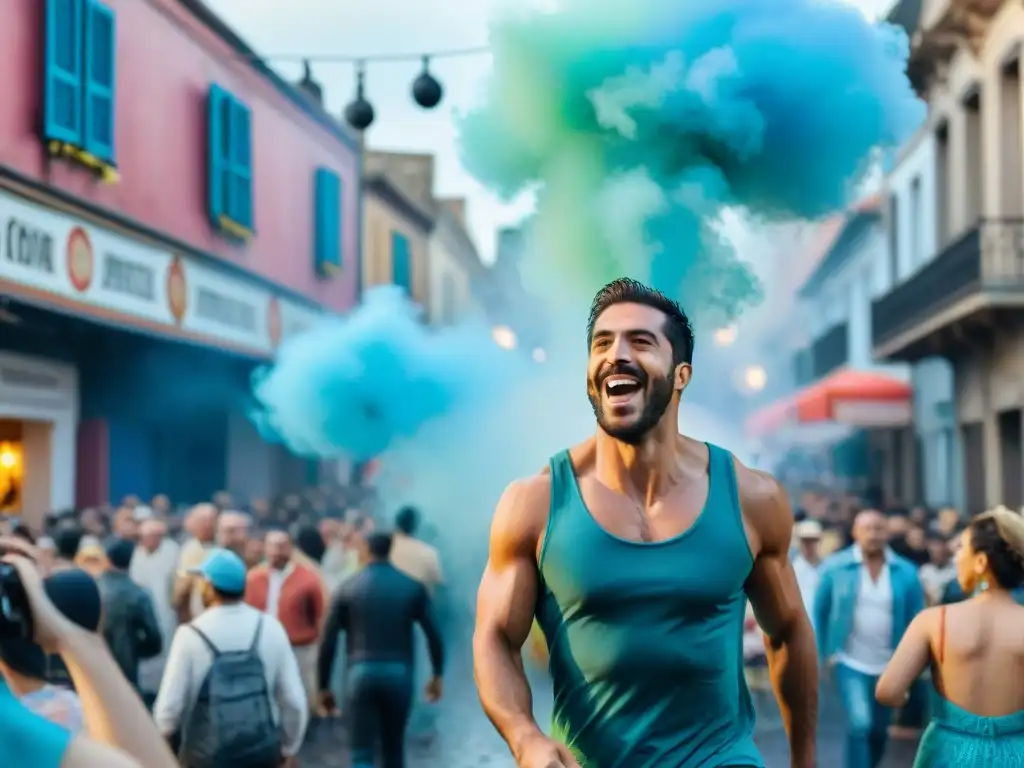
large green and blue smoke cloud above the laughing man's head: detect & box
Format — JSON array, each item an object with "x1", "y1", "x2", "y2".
[{"x1": 461, "y1": 0, "x2": 924, "y2": 315}]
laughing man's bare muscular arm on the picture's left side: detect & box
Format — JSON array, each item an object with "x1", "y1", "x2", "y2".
[{"x1": 473, "y1": 477, "x2": 550, "y2": 759}]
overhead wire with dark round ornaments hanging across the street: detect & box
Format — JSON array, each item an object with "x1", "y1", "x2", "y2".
[{"x1": 259, "y1": 46, "x2": 490, "y2": 132}]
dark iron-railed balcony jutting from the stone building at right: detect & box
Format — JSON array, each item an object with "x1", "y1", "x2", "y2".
[{"x1": 871, "y1": 219, "x2": 1024, "y2": 359}]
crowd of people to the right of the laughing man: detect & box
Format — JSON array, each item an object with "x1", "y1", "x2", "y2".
[{"x1": 765, "y1": 488, "x2": 1024, "y2": 768}]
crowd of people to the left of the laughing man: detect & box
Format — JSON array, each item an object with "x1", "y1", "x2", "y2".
[{"x1": 0, "y1": 488, "x2": 443, "y2": 768}]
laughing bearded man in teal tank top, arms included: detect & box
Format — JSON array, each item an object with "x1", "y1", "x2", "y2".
[{"x1": 474, "y1": 280, "x2": 818, "y2": 768}]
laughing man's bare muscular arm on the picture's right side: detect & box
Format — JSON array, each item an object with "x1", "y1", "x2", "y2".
[{"x1": 737, "y1": 467, "x2": 818, "y2": 768}]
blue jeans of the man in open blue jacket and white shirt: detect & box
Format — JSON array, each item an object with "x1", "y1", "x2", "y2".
[{"x1": 835, "y1": 664, "x2": 892, "y2": 768}]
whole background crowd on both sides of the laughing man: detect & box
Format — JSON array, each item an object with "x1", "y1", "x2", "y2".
[{"x1": 6, "y1": 475, "x2": 1024, "y2": 768}]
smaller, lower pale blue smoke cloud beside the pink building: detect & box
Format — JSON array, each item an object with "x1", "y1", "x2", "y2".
[{"x1": 247, "y1": 286, "x2": 519, "y2": 461}]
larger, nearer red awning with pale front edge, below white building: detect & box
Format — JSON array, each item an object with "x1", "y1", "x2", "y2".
[{"x1": 794, "y1": 369, "x2": 913, "y2": 427}]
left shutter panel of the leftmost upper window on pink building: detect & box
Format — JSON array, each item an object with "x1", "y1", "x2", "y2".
[{"x1": 43, "y1": 0, "x2": 83, "y2": 145}]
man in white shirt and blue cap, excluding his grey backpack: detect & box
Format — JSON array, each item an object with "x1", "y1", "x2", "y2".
[{"x1": 153, "y1": 549, "x2": 309, "y2": 761}]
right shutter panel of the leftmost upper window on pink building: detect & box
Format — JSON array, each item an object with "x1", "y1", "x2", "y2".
[{"x1": 82, "y1": 0, "x2": 118, "y2": 163}]
